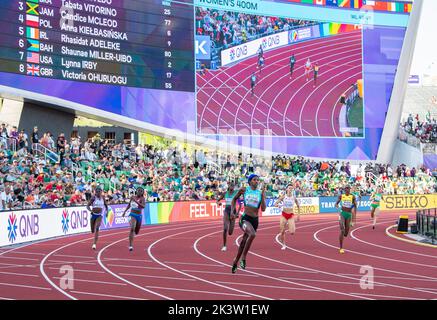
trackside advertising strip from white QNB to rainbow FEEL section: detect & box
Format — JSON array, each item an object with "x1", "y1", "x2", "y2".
[{"x1": 0, "y1": 201, "x2": 224, "y2": 247}]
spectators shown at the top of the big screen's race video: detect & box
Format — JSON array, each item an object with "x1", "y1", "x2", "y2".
[{"x1": 196, "y1": 7, "x2": 312, "y2": 48}]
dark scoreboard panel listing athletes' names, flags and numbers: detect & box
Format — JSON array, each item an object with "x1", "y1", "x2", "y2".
[{"x1": 0, "y1": 0, "x2": 194, "y2": 91}]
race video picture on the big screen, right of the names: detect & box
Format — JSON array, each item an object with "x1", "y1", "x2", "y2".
[{"x1": 196, "y1": 8, "x2": 364, "y2": 137}]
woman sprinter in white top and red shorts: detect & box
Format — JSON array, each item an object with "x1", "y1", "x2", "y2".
[{"x1": 274, "y1": 185, "x2": 300, "y2": 250}]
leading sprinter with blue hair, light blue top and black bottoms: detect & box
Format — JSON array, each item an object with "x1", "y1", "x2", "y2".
[{"x1": 231, "y1": 174, "x2": 266, "y2": 273}]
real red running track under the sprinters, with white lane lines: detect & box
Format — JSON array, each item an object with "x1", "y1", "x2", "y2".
[{"x1": 0, "y1": 213, "x2": 437, "y2": 300}]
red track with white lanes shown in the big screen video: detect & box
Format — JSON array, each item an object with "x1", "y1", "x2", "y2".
[{"x1": 197, "y1": 31, "x2": 362, "y2": 137}]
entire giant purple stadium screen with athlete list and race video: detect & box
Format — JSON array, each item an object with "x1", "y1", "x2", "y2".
[{"x1": 0, "y1": 0, "x2": 412, "y2": 160}]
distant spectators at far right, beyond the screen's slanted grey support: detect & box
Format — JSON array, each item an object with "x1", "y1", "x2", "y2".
[{"x1": 401, "y1": 112, "x2": 437, "y2": 143}]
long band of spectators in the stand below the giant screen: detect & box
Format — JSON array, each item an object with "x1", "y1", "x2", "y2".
[{"x1": 0, "y1": 125, "x2": 437, "y2": 210}]
